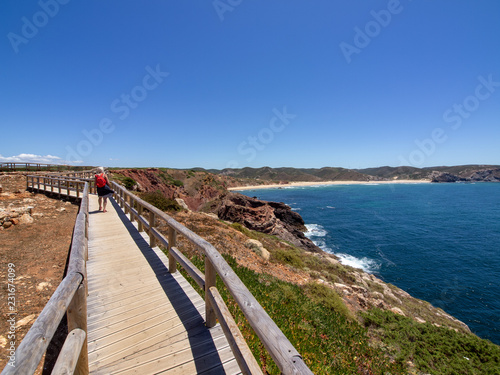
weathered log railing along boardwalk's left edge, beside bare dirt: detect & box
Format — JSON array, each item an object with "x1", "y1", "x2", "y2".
[{"x1": 2, "y1": 180, "x2": 89, "y2": 375}]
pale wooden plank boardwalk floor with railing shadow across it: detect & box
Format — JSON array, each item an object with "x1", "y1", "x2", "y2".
[{"x1": 87, "y1": 195, "x2": 241, "y2": 375}]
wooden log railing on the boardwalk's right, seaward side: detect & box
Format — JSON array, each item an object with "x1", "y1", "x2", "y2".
[{"x1": 111, "y1": 182, "x2": 312, "y2": 374}]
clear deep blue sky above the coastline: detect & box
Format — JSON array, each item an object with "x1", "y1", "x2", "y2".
[{"x1": 0, "y1": 0, "x2": 500, "y2": 169}]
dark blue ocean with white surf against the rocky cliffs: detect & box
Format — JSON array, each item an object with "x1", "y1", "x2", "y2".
[{"x1": 241, "y1": 183, "x2": 500, "y2": 345}]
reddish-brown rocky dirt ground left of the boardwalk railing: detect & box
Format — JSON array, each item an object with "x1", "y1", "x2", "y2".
[{"x1": 0, "y1": 174, "x2": 78, "y2": 373}]
